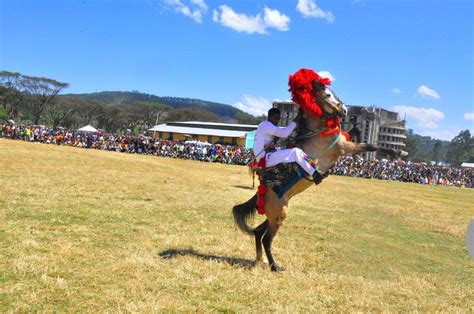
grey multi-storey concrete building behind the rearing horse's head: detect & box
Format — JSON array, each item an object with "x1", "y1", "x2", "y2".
[{"x1": 273, "y1": 101, "x2": 406, "y2": 159}]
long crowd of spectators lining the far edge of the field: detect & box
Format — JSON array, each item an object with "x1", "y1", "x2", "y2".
[{"x1": 0, "y1": 124, "x2": 474, "y2": 188}]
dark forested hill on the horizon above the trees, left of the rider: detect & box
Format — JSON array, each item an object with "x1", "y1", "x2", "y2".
[{"x1": 65, "y1": 91, "x2": 243, "y2": 120}]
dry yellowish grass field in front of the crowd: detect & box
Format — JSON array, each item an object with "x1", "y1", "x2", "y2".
[{"x1": 0, "y1": 139, "x2": 474, "y2": 312}]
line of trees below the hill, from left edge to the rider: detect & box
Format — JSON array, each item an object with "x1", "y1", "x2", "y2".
[{"x1": 0, "y1": 71, "x2": 265, "y2": 134}]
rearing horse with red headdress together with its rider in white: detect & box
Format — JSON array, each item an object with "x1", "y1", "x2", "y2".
[{"x1": 232, "y1": 69, "x2": 406, "y2": 271}]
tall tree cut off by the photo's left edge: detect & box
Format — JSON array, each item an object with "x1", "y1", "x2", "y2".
[{"x1": 0, "y1": 71, "x2": 24, "y2": 120}]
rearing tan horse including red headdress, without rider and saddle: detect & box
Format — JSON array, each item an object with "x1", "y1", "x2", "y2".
[{"x1": 232, "y1": 69, "x2": 406, "y2": 271}]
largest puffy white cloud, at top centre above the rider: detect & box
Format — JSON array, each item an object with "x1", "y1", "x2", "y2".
[{"x1": 212, "y1": 5, "x2": 290, "y2": 34}]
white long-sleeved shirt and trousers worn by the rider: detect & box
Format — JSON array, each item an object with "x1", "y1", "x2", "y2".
[{"x1": 253, "y1": 120, "x2": 315, "y2": 175}]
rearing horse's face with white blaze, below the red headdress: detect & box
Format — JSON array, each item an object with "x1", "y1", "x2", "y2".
[{"x1": 313, "y1": 80, "x2": 347, "y2": 118}]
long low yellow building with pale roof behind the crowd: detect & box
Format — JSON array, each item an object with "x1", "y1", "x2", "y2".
[{"x1": 148, "y1": 121, "x2": 258, "y2": 146}]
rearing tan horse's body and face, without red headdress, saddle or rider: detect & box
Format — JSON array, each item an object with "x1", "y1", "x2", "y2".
[{"x1": 232, "y1": 81, "x2": 406, "y2": 272}]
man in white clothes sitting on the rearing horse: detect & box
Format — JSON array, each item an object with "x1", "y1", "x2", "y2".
[{"x1": 253, "y1": 108, "x2": 324, "y2": 184}]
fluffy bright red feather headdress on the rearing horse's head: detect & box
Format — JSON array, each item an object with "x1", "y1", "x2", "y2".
[{"x1": 288, "y1": 69, "x2": 331, "y2": 117}]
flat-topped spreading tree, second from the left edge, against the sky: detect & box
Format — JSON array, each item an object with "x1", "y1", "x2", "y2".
[{"x1": 22, "y1": 75, "x2": 69, "y2": 124}]
